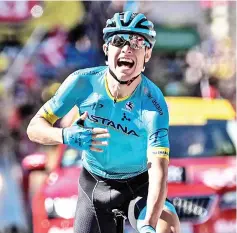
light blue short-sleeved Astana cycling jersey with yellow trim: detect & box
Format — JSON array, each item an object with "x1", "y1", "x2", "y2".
[{"x1": 42, "y1": 66, "x2": 169, "y2": 179}]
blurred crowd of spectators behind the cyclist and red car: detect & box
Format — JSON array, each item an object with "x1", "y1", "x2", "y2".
[{"x1": 0, "y1": 1, "x2": 236, "y2": 160}]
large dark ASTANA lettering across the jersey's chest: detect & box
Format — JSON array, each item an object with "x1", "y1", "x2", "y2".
[{"x1": 88, "y1": 115, "x2": 139, "y2": 137}]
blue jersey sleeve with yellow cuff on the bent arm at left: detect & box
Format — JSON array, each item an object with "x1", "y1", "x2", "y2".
[{"x1": 40, "y1": 71, "x2": 88, "y2": 125}]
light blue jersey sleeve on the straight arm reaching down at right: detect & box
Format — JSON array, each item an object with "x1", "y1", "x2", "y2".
[{"x1": 143, "y1": 89, "x2": 169, "y2": 160}]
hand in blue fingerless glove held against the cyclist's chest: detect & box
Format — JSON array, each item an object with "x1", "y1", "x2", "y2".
[{"x1": 62, "y1": 112, "x2": 110, "y2": 152}]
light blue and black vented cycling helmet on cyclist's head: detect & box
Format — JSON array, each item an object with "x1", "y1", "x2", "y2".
[{"x1": 103, "y1": 11, "x2": 156, "y2": 48}]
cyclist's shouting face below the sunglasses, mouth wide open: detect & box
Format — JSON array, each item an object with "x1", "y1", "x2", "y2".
[{"x1": 103, "y1": 36, "x2": 152, "y2": 81}]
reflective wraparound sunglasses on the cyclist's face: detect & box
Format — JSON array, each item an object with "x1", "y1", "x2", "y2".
[{"x1": 108, "y1": 34, "x2": 150, "y2": 49}]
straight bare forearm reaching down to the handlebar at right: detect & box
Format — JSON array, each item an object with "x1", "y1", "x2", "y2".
[{"x1": 145, "y1": 166, "x2": 167, "y2": 228}]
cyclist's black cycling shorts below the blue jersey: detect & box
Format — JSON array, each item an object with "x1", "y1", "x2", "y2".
[{"x1": 74, "y1": 168, "x2": 174, "y2": 233}]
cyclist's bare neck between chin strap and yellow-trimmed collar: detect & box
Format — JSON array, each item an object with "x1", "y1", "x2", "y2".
[{"x1": 107, "y1": 72, "x2": 142, "y2": 98}]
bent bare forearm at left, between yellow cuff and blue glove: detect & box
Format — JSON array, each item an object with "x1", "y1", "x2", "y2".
[{"x1": 27, "y1": 116, "x2": 63, "y2": 145}]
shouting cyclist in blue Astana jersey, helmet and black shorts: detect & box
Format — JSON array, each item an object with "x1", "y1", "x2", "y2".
[{"x1": 27, "y1": 11, "x2": 180, "y2": 233}]
